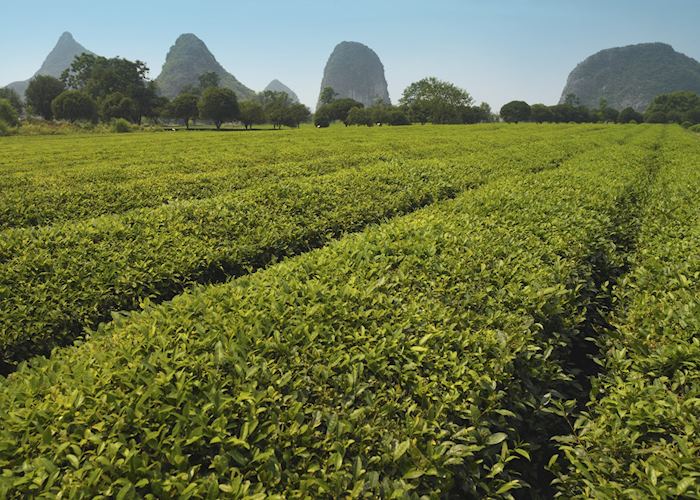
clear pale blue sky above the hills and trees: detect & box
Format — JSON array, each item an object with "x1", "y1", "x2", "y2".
[{"x1": 0, "y1": 0, "x2": 700, "y2": 110}]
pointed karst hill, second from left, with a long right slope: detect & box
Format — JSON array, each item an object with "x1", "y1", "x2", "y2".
[{"x1": 156, "y1": 33, "x2": 255, "y2": 99}]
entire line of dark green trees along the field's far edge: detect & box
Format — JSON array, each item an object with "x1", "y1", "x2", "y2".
[{"x1": 0, "y1": 54, "x2": 700, "y2": 133}]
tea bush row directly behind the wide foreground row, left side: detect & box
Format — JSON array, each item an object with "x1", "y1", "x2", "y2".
[{"x1": 0, "y1": 126, "x2": 614, "y2": 373}]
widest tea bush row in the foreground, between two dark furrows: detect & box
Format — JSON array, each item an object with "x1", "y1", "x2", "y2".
[{"x1": 0, "y1": 130, "x2": 651, "y2": 498}]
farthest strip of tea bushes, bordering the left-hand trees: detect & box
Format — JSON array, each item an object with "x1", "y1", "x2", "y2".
[{"x1": 0, "y1": 124, "x2": 584, "y2": 230}]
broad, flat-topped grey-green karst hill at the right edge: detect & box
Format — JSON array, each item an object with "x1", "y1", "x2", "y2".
[{"x1": 560, "y1": 43, "x2": 700, "y2": 111}]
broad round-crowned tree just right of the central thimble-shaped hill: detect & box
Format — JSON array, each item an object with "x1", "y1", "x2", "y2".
[{"x1": 399, "y1": 77, "x2": 474, "y2": 124}]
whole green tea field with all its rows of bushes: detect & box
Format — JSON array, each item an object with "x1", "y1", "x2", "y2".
[{"x1": 0, "y1": 124, "x2": 700, "y2": 498}]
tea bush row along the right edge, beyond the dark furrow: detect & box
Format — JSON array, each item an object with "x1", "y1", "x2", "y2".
[{"x1": 559, "y1": 129, "x2": 700, "y2": 498}]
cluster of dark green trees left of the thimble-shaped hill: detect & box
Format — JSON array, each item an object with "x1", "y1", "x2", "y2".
[{"x1": 0, "y1": 54, "x2": 311, "y2": 129}]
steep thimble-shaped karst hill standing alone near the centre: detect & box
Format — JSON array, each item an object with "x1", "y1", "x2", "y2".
[{"x1": 321, "y1": 42, "x2": 391, "y2": 106}]
